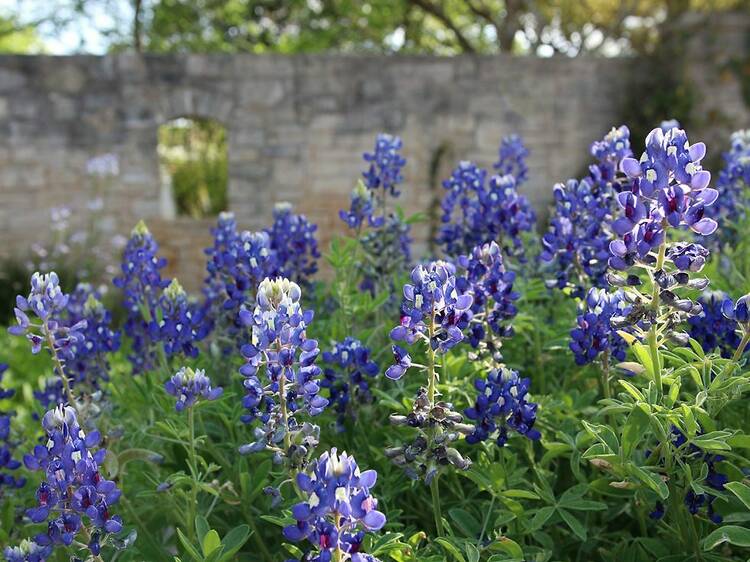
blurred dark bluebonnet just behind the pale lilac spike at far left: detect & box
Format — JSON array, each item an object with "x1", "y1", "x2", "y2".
[{"x1": 66, "y1": 283, "x2": 120, "y2": 388}]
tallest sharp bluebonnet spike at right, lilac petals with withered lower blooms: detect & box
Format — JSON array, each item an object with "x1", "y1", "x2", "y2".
[{"x1": 609, "y1": 128, "x2": 718, "y2": 341}]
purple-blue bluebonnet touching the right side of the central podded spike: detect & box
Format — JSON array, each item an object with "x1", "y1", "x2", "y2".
[{"x1": 456, "y1": 242, "x2": 519, "y2": 348}]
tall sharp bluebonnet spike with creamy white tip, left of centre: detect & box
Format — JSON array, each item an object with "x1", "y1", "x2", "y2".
[{"x1": 240, "y1": 278, "x2": 328, "y2": 463}]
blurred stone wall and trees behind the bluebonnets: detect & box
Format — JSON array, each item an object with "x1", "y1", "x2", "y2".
[{"x1": 0, "y1": 0, "x2": 750, "y2": 302}]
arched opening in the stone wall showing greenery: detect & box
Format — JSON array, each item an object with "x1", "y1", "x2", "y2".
[{"x1": 158, "y1": 117, "x2": 229, "y2": 219}]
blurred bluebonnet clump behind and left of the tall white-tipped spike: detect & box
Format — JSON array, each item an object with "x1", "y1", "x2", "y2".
[{"x1": 204, "y1": 213, "x2": 276, "y2": 339}]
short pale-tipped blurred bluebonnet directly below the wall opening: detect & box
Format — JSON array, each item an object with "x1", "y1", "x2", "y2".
[{"x1": 148, "y1": 279, "x2": 210, "y2": 357}]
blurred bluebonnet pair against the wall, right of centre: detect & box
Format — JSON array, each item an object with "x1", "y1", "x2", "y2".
[{"x1": 437, "y1": 162, "x2": 536, "y2": 259}]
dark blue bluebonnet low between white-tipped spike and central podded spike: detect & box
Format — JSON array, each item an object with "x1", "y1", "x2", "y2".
[{"x1": 320, "y1": 337, "x2": 378, "y2": 431}]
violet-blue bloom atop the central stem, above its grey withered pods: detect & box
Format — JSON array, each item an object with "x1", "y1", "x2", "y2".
[{"x1": 385, "y1": 261, "x2": 473, "y2": 379}]
